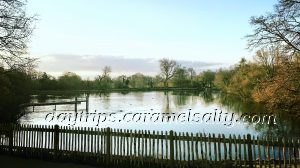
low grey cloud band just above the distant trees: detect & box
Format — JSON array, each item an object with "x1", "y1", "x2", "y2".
[{"x1": 38, "y1": 54, "x2": 221, "y2": 77}]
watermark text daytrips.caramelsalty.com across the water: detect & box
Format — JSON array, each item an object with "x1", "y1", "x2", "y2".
[{"x1": 45, "y1": 109, "x2": 276, "y2": 127}]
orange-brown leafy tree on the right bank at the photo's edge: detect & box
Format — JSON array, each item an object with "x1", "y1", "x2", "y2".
[{"x1": 252, "y1": 51, "x2": 300, "y2": 112}]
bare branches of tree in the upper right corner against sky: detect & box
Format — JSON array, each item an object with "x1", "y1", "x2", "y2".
[{"x1": 246, "y1": 0, "x2": 300, "y2": 55}]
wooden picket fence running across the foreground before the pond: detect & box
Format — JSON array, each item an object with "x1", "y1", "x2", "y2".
[{"x1": 0, "y1": 124, "x2": 300, "y2": 168}]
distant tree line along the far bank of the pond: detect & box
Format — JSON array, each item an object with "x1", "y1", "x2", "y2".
[{"x1": 29, "y1": 58, "x2": 214, "y2": 91}]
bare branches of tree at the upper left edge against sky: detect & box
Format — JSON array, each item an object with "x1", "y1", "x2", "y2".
[{"x1": 0, "y1": 0, "x2": 36, "y2": 70}]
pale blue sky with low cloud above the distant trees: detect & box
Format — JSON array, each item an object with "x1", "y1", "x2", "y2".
[{"x1": 27, "y1": 0, "x2": 277, "y2": 78}]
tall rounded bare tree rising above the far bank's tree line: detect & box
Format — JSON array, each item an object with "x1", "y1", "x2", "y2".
[{"x1": 159, "y1": 58, "x2": 178, "y2": 87}]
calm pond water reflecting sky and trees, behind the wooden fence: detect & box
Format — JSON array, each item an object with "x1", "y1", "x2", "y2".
[{"x1": 18, "y1": 91, "x2": 300, "y2": 137}]
